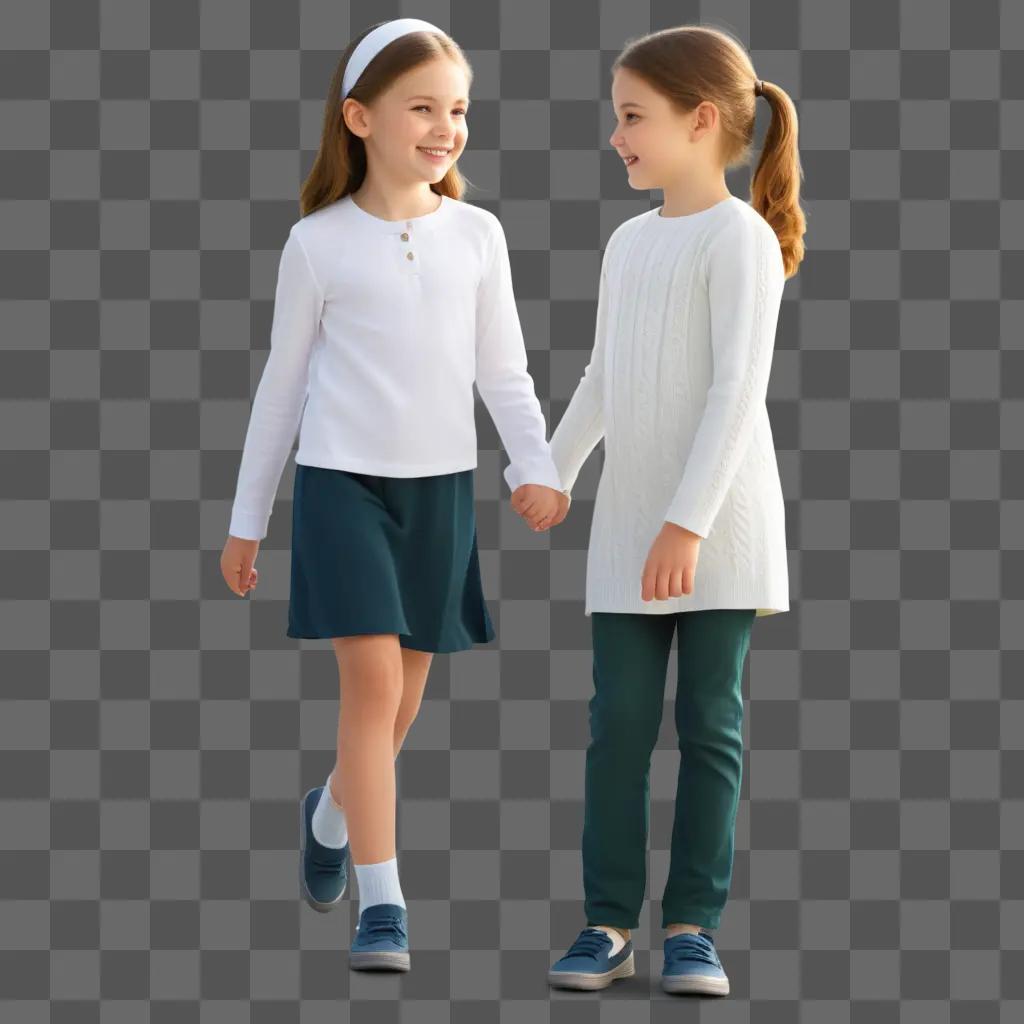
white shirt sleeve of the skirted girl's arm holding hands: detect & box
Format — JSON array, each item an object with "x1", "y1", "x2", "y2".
[{"x1": 476, "y1": 217, "x2": 560, "y2": 490}]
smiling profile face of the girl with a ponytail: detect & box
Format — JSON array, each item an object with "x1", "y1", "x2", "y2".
[{"x1": 608, "y1": 68, "x2": 718, "y2": 188}]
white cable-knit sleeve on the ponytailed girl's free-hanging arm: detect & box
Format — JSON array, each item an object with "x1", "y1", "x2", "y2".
[{"x1": 665, "y1": 217, "x2": 785, "y2": 537}]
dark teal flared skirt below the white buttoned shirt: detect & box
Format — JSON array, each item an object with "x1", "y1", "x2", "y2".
[{"x1": 288, "y1": 463, "x2": 495, "y2": 653}]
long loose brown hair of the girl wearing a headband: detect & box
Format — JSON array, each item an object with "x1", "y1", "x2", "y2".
[{"x1": 299, "y1": 22, "x2": 473, "y2": 217}]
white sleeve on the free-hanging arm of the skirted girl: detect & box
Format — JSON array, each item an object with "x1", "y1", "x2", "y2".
[{"x1": 228, "y1": 226, "x2": 324, "y2": 541}]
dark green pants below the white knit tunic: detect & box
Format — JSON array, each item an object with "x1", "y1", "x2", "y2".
[{"x1": 582, "y1": 608, "x2": 755, "y2": 929}]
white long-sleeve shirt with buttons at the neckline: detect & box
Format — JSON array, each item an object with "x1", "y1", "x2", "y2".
[{"x1": 228, "y1": 196, "x2": 559, "y2": 540}]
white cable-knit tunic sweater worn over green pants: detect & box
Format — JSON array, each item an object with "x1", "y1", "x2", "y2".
[{"x1": 551, "y1": 196, "x2": 790, "y2": 615}]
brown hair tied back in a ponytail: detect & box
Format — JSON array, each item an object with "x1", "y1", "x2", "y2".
[{"x1": 611, "y1": 25, "x2": 807, "y2": 278}]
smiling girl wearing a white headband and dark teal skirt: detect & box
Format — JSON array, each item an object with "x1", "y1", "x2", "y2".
[{"x1": 221, "y1": 18, "x2": 563, "y2": 971}]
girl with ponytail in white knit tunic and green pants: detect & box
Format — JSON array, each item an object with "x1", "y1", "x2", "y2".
[{"x1": 548, "y1": 26, "x2": 804, "y2": 995}]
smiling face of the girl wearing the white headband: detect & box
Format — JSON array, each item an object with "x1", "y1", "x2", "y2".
[{"x1": 344, "y1": 56, "x2": 469, "y2": 184}]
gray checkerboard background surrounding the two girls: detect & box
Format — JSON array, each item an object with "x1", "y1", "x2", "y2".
[{"x1": 0, "y1": 0, "x2": 1024, "y2": 1011}]
